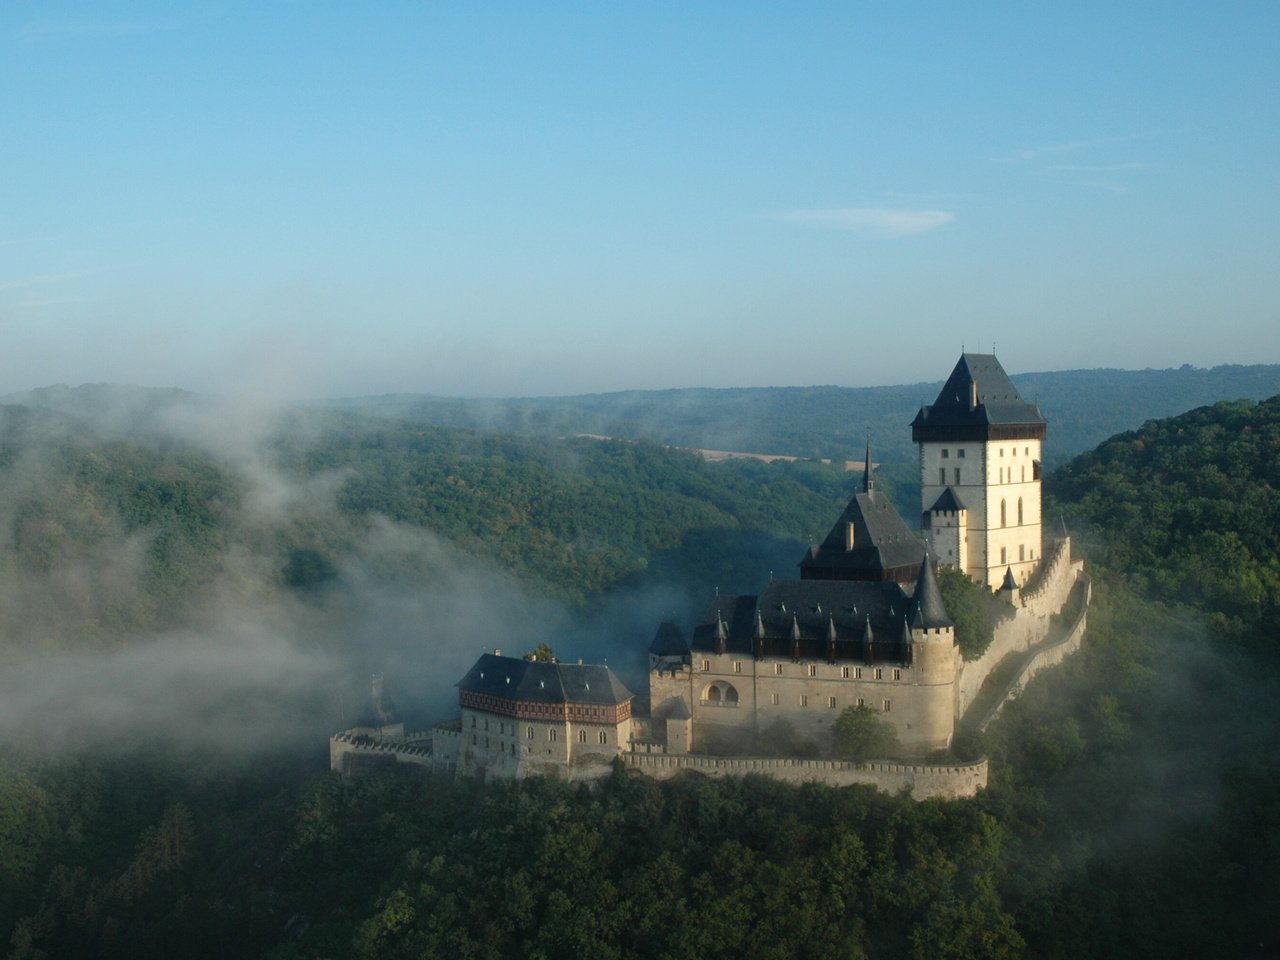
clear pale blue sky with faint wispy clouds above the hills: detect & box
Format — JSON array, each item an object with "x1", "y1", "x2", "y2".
[{"x1": 0, "y1": 0, "x2": 1280, "y2": 397}]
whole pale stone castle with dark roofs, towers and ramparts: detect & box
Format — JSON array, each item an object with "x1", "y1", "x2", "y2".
[{"x1": 330, "y1": 353, "x2": 1084, "y2": 795}]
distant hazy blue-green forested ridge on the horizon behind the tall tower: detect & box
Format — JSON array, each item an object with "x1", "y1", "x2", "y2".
[{"x1": 322, "y1": 365, "x2": 1280, "y2": 466}]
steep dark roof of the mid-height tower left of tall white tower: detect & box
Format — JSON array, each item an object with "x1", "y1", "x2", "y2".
[{"x1": 800, "y1": 488, "x2": 924, "y2": 582}]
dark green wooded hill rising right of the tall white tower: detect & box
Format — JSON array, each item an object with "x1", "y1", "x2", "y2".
[{"x1": 1048, "y1": 396, "x2": 1280, "y2": 657}]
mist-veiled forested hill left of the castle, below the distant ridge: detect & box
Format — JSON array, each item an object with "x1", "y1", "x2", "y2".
[{"x1": 0, "y1": 399, "x2": 856, "y2": 648}]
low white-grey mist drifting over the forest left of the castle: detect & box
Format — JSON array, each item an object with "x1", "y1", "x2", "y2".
[{"x1": 0, "y1": 394, "x2": 685, "y2": 754}]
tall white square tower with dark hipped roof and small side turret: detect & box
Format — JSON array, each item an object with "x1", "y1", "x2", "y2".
[{"x1": 911, "y1": 353, "x2": 1048, "y2": 588}]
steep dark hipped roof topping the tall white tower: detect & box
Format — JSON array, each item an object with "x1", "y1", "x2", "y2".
[{"x1": 911, "y1": 353, "x2": 1046, "y2": 440}]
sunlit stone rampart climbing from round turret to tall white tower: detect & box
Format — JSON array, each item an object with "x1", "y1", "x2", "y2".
[{"x1": 956, "y1": 538, "x2": 1084, "y2": 718}]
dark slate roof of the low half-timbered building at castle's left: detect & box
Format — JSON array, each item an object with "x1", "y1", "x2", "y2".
[{"x1": 456, "y1": 653, "x2": 635, "y2": 705}]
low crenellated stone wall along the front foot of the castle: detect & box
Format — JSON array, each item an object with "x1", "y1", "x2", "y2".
[{"x1": 622, "y1": 753, "x2": 987, "y2": 800}]
